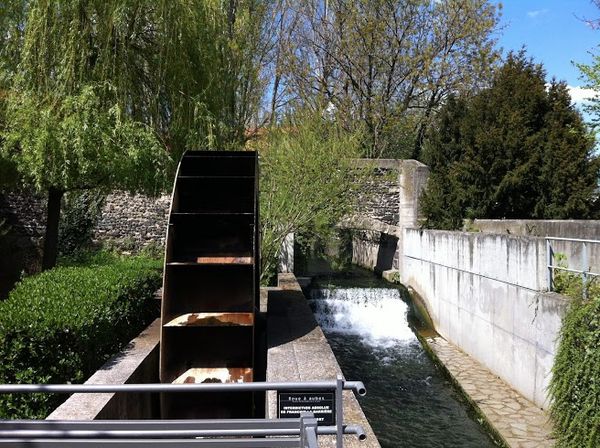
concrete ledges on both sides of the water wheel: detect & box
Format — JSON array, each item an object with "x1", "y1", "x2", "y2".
[{"x1": 48, "y1": 274, "x2": 380, "y2": 448}]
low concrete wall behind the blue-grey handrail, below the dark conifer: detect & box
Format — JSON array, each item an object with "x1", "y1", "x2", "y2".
[{"x1": 465, "y1": 219, "x2": 600, "y2": 273}]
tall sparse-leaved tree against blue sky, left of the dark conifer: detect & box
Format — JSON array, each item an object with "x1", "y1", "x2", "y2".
[{"x1": 275, "y1": 0, "x2": 498, "y2": 158}]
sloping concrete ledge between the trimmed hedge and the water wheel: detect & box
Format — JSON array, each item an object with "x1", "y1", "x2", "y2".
[{"x1": 47, "y1": 319, "x2": 160, "y2": 420}]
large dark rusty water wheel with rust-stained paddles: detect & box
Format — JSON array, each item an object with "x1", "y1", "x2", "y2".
[{"x1": 160, "y1": 151, "x2": 264, "y2": 418}]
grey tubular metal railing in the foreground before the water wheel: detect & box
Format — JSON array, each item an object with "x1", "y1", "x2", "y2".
[{"x1": 0, "y1": 377, "x2": 366, "y2": 448}]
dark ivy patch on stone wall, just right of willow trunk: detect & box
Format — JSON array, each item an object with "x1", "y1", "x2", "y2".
[{"x1": 58, "y1": 190, "x2": 105, "y2": 255}]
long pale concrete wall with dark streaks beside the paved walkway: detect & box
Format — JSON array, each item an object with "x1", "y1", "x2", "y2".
[{"x1": 401, "y1": 229, "x2": 568, "y2": 408}]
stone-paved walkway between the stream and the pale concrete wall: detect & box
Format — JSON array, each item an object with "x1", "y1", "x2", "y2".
[{"x1": 425, "y1": 336, "x2": 554, "y2": 448}]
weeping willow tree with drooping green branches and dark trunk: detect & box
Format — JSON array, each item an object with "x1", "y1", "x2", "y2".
[{"x1": 0, "y1": 0, "x2": 265, "y2": 268}]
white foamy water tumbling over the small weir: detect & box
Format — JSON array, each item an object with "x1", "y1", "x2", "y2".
[{"x1": 310, "y1": 288, "x2": 416, "y2": 347}]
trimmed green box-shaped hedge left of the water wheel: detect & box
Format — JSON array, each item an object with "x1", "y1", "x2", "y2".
[{"x1": 0, "y1": 257, "x2": 161, "y2": 418}]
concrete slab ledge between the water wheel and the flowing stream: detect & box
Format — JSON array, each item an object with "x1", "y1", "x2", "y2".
[{"x1": 267, "y1": 274, "x2": 380, "y2": 448}]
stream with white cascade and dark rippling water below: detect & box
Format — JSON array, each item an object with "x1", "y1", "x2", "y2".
[{"x1": 310, "y1": 282, "x2": 496, "y2": 448}]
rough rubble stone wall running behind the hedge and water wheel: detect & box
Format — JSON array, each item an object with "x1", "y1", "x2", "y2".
[{"x1": 0, "y1": 159, "x2": 410, "y2": 280}]
